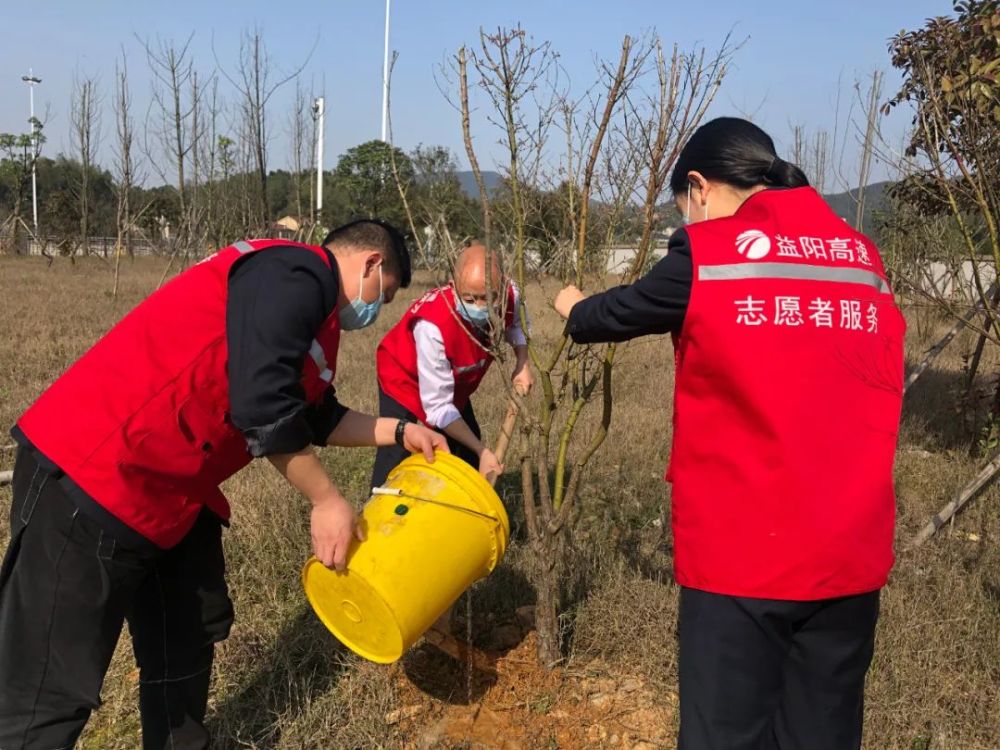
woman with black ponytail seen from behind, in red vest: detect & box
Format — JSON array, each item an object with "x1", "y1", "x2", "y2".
[{"x1": 555, "y1": 117, "x2": 905, "y2": 750}]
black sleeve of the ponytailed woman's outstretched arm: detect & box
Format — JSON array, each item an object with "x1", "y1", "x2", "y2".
[{"x1": 566, "y1": 229, "x2": 692, "y2": 344}]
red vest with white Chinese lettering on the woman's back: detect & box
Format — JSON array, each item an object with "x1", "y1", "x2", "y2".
[{"x1": 667, "y1": 188, "x2": 905, "y2": 600}]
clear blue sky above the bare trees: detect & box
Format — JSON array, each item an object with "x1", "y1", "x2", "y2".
[{"x1": 0, "y1": 0, "x2": 951, "y2": 188}]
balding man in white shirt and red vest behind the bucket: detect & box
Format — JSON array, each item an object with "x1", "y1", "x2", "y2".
[{"x1": 372, "y1": 245, "x2": 534, "y2": 487}]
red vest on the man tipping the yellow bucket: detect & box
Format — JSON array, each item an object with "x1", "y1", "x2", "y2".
[{"x1": 18, "y1": 240, "x2": 340, "y2": 548}]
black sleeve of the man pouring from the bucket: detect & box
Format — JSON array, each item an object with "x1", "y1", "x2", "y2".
[{"x1": 226, "y1": 247, "x2": 346, "y2": 456}]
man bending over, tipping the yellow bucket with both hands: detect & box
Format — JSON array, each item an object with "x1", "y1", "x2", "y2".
[{"x1": 0, "y1": 220, "x2": 448, "y2": 750}]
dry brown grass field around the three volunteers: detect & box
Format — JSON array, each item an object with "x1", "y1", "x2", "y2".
[{"x1": 0, "y1": 258, "x2": 1000, "y2": 750}]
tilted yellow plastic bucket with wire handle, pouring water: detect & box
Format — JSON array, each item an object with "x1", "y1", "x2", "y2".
[{"x1": 302, "y1": 453, "x2": 510, "y2": 664}]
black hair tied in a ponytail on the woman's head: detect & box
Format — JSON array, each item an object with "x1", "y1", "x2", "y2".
[{"x1": 670, "y1": 117, "x2": 809, "y2": 195}]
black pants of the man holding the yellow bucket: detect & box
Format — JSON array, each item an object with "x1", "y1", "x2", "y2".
[{"x1": 0, "y1": 450, "x2": 233, "y2": 750}]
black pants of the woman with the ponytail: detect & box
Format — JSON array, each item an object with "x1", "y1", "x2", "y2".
[{"x1": 677, "y1": 588, "x2": 879, "y2": 750}]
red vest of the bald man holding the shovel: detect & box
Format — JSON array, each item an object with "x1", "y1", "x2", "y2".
[{"x1": 375, "y1": 284, "x2": 518, "y2": 421}]
